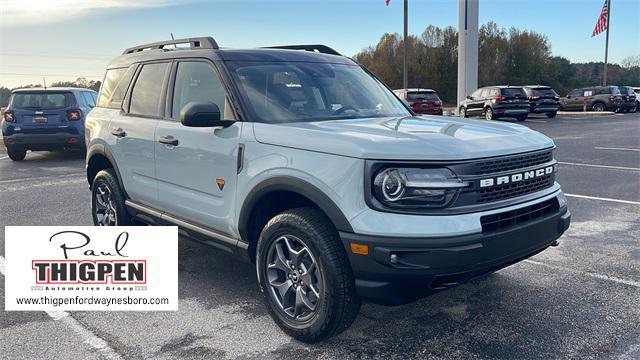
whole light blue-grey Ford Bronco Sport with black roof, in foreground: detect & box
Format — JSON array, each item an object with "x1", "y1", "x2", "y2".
[{"x1": 86, "y1": 38, "x2": 570, "y2": 342}]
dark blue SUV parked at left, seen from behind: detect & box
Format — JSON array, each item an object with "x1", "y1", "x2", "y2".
[{"x1": 2, "y1": 88, "x2": 97, "y2": 161}]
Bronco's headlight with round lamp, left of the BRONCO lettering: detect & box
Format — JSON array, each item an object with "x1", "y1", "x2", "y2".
[{"x1": 373, "y1": 167, "x2": 469, "y2": 209}]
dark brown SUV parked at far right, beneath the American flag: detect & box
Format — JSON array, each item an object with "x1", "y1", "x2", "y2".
[{"x1": 560, "y1": 86, "x2": 622, "y2": 111}]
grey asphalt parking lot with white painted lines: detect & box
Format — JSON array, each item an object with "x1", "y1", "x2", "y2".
[{"x1": 0, "y1": 114, "x2": 640, "y2": 359}]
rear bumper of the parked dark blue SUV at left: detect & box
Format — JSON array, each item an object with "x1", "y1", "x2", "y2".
[{"x1": 2, "y1": 132, "x2": 85, "y2": 151}]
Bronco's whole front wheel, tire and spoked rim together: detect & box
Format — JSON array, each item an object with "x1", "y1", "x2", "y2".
[{"x1": 256, "y1": 208, "x2": 360, "y2": 342}]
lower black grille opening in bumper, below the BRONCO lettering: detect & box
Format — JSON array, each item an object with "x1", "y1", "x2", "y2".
[{"x1": 480, "y1": 197, "x2": 560, "y2": 233}]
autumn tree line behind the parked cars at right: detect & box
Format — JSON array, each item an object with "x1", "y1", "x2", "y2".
[{"x1": 354, "y1": 22, "x2": 640, "y2": 104}]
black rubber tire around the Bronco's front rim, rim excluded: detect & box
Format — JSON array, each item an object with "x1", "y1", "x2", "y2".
[{"x1": 256, "y1": 208, "x2": 361, "y2": 343}]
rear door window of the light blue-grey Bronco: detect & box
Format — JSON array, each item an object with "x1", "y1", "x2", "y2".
[{"x1": 129, "y1": 63, "x2": 169, "y2": 117}]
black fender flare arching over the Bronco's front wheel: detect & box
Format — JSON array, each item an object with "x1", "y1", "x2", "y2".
[{"x1": 238, "y1": 176, "x2": 353, "y2": 240}]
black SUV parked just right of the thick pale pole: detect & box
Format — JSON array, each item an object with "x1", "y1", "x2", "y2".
[{"x1": 458, "y1": 86, "x2": 529, "y2": 121}]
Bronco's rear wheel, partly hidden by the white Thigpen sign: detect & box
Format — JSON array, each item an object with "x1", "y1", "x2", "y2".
[{"x1": 91, "y1": 169, "x2": 131, "y2": 226}]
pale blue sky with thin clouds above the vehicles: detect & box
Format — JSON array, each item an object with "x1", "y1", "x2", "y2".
[{"x1": 0, "y1": 0, "x2": 640, "y2": 88}]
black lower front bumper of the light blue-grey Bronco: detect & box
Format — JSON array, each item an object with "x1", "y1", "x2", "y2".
[{"x1": 340, "y1": 206, "x2": 571, "y2": 305}]
